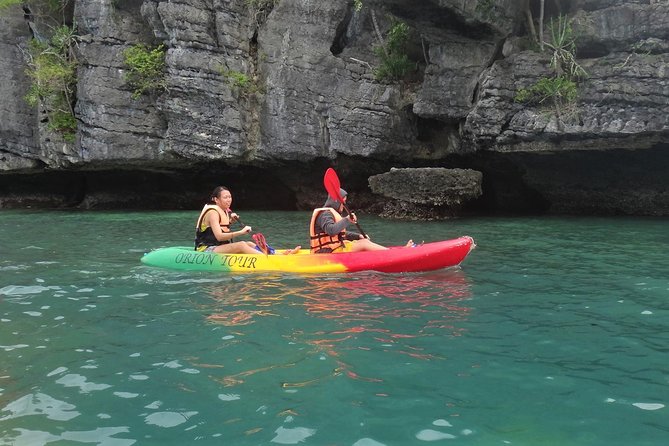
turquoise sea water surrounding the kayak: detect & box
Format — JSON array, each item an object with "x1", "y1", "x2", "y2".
[{"x1": 0, "y1": 211, "x2": 669, "y2": 446}]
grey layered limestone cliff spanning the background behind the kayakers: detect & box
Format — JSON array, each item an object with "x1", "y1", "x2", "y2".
[{"x1": 0, "y1": 0, "x2": 669, "y2": 218}]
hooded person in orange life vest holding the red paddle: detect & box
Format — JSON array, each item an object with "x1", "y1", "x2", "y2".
[{"x1": 309, "y1": 189, "x2": 413, "y2": 254}]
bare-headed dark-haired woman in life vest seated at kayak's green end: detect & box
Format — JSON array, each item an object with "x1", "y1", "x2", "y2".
[{"x1": 195, "y1": 186, "x2": 300, "y2": 254}]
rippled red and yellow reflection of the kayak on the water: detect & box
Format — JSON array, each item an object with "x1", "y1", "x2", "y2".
[{"x1": 202, "y1": 269, "x2": 471, "y2": 388}]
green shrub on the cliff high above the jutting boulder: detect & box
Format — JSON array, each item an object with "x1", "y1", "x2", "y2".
[{"x1": 374, "y1": 21, "x2": 416, "y2": 81}]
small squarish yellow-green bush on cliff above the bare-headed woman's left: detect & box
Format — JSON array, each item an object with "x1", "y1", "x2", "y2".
[{"x1": 123, "y1": 43, "x2": 167, "y2": 99}]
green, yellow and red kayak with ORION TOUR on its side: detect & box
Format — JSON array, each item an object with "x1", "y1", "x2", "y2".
[{"x1": 141, "y1": 236, "x2": 476, "y2": 273}]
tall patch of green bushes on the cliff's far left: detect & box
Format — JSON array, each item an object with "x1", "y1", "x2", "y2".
[{"x1": 25, "y1": 25, "x2": 77, "y2": 141}]
